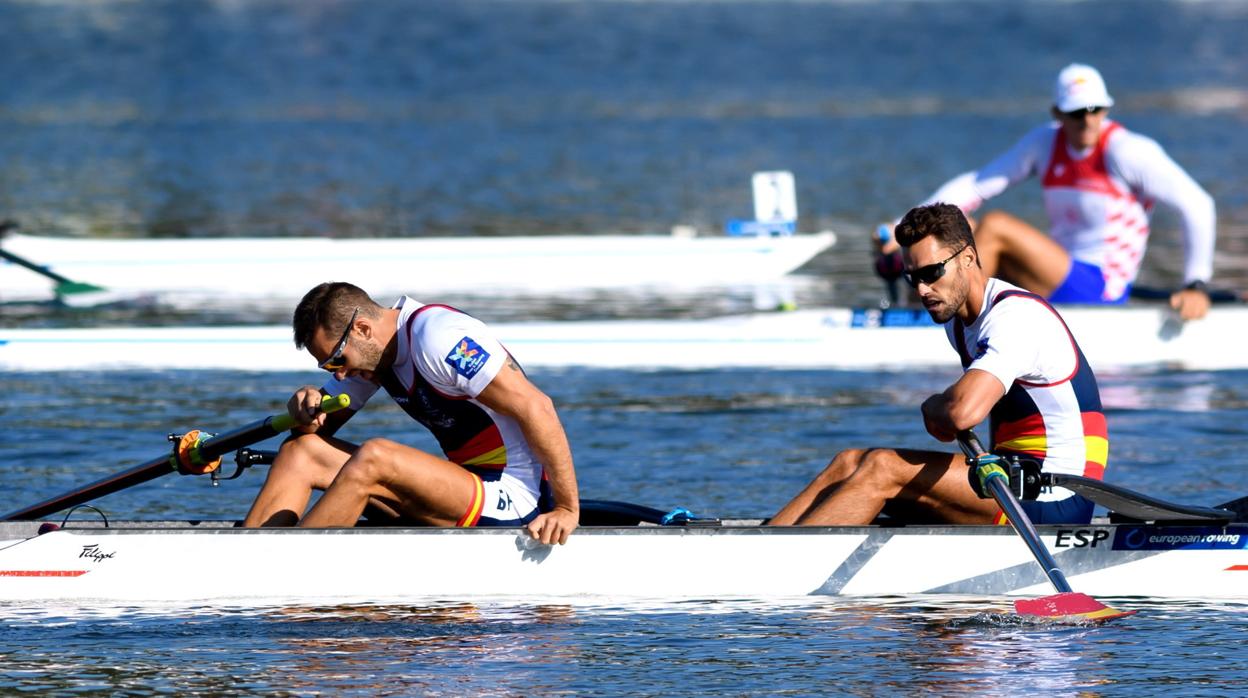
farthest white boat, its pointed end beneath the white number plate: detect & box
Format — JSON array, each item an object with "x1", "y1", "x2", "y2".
[{"x1": 0, "y1": 231, "x2": 836, "y2": 307}]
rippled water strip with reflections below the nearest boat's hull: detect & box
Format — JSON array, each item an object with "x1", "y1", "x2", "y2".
[{"x1": 0, "y1": 597, "x2": 1248, "y2": 696}]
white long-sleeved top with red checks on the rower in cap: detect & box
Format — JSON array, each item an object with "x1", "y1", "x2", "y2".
[{"x1": 924, "y1": 119, "x2": 1216, "y2": 300}]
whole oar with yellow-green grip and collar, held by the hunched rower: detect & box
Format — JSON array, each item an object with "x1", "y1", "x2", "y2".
[{"x1": 0, "y1": 393, "x2": 351, "y2": 521}]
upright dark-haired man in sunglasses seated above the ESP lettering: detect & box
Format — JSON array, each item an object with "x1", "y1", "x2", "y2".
[{"x1": 770, "y1": 204, "x2": 1109, "y2": 526}]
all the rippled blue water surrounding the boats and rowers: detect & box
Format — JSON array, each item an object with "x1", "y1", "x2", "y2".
[{"x1": 0, "y1": 0, "x2": 1248, "y2": 696}]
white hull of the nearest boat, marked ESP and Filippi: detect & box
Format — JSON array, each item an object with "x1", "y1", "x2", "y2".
[{"x1": 0, "y1": 522, "x2": 1248, "y2": 603}]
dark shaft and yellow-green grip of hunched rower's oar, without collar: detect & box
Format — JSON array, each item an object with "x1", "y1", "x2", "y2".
[{"x1": 0, "y1": 395, "x2": 351, "y2": 521}]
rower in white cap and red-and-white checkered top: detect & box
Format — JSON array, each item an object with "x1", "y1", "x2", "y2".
[{"x1": 876, "y1": 64, "x2": 1216, "y2": 320}]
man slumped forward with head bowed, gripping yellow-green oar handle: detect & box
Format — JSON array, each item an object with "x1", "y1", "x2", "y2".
[{"x1": 243, "y1": 282, "x2": 580, "y2": 543}]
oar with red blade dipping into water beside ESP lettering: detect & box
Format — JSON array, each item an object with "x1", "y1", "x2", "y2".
[{"x1": 957, "y1": 430, "x2": 1134, "y2": 622}]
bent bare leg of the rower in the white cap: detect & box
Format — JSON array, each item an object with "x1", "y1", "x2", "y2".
[{"x1": 975, "y1": 211, "x2": 1071, "y2": 297}]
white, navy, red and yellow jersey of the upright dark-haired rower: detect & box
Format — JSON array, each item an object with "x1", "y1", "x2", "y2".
[{"x1": 945, "y1": 278, "x2": 1109, "y2": 501}]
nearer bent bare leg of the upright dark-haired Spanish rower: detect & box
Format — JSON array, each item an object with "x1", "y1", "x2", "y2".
[{"x1": 778, "y1": 448, "x2": 997, "y2": 526}]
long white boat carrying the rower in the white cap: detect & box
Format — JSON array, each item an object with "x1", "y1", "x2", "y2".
[{"x1": 0, "y1": 305, "x2": 1248, "y2": 371}]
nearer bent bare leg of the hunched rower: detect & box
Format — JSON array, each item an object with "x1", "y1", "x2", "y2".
[{"x1": 300, "y1": 438, "x2": 477, "y2": 527}]
